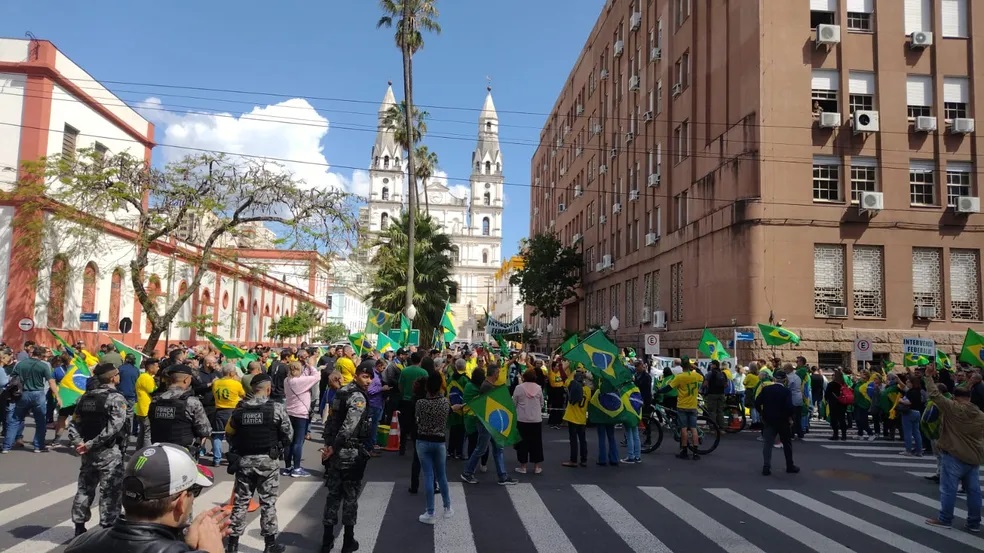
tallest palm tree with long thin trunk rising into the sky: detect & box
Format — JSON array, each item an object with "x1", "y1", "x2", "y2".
[{"x1": 376, "y1": 0, "x2": 441, "y2": 316}]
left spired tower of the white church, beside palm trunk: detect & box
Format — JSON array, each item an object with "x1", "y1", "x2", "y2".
[{"x1": 368, "y1": 82, "x2": 406, "y2": 233}]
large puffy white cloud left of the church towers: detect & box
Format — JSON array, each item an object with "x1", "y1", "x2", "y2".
[{"x1": 136, "y1": 97, "x2": 369, "y2": 195}]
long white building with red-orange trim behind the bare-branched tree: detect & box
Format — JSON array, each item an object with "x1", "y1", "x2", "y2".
[{"x1": 0, "y1": 39, "x2": 327, "y2": 346}]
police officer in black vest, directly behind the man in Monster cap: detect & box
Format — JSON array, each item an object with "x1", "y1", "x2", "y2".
[{"x1": 147, "y1": 365, "x2": 212, "y2": 460}]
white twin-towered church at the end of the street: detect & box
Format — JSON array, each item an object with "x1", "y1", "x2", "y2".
[{"x1": 359, "y1": 86, "x2": 503, "y2": 341}]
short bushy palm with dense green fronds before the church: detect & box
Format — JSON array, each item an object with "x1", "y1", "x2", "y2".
[{"x1": 366, "y1": 214, "x2": 454, "y2": 336}]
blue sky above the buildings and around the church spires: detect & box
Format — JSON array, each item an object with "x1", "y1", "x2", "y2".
[{"x1": 0, "y1": 0, "x2": 604, "y2": 256}]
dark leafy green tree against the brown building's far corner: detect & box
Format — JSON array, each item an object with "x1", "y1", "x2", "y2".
[{"x1": 509, "y1": 233, "x2": 584, "y2": 319}]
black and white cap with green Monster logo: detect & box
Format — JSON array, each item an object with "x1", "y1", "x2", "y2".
[{"x1": 123, "y1": 443, "x2": 213, "y2": 500}]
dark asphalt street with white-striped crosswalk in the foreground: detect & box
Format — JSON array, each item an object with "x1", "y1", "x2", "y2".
[{"x1": 0, "y1": 418, "x2": 984, "y2": 553}]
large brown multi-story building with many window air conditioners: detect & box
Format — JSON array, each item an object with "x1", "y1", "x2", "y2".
[{"x1": 531, "y1": 0, "x2": 984, "y2": 365}]
